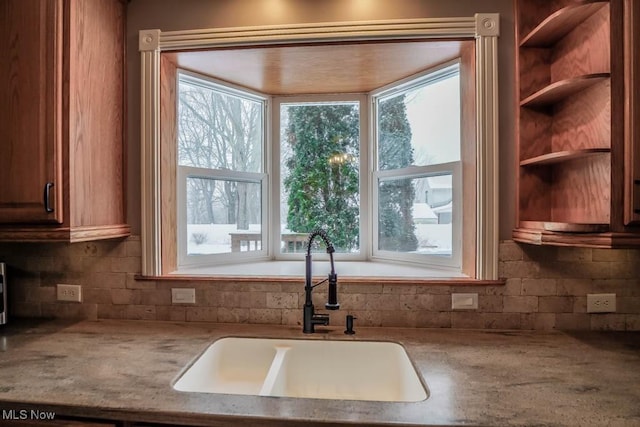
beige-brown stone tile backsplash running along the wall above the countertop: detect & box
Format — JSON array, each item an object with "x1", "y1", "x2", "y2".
[{"x1": 0, "y1": 236, "x2": 640, "y2": 330}]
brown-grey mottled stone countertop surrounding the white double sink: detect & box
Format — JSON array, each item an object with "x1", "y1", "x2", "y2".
[{"x1": 0, "y1": 320, "x2": 640, "y2": 426}]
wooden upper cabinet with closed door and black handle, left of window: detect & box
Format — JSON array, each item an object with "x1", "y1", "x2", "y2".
[{"x1": 0, "y1": 0, "x2": 130, "y2": 241}]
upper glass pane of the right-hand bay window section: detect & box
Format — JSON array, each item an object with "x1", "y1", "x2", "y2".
[{"x1": 377, "y1": 73, "x2": 460, "y2": 170}]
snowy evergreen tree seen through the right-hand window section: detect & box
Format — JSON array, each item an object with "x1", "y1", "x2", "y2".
[{"x1": 378, "y1": 95, "x2": 418, "y2": 252}]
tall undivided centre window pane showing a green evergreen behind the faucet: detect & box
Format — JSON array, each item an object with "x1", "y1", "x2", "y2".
[{"x1": 280, "y1": 102, "x2": 360, "y2": 253}]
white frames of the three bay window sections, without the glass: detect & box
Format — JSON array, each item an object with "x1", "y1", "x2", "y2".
[{"x1": 177, "y1": 72, "x2": 464, "y2": 273}]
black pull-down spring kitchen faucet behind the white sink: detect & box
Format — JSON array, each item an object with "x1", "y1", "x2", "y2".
[{"x1": 302, "y1": 229, "x2": 340, "y2": 334}]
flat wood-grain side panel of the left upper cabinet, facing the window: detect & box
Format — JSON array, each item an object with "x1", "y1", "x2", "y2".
[{"x1": 68, "y1": 0, "x2": 125, "y2": 227}]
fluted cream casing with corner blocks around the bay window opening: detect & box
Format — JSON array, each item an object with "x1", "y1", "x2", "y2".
[{"x1": 139, "y1": 13, "x2": 500, "y2": 280}]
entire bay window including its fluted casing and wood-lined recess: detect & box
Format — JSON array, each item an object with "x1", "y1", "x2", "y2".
[{"x1": 140, "y1": 14, "x2": 498, "y2": 279}]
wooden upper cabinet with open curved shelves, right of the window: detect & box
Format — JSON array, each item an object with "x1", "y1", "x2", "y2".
[{"x1": 513, "y1": 0, "x2": 640, "y2": 247}]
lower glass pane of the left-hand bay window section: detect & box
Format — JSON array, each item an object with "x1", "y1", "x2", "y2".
[{"x1": 185, "y1": 177, "x2": 262, "y2": 255}]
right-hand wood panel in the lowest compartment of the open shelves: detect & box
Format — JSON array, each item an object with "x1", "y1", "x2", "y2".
[{"x1": 551, "y1": 154, "x2": 611, "y2": 224}]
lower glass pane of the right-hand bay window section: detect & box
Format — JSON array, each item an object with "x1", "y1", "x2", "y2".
[{"x1": 378, "y1": 174, "x2": 454, "y2": 256}]
